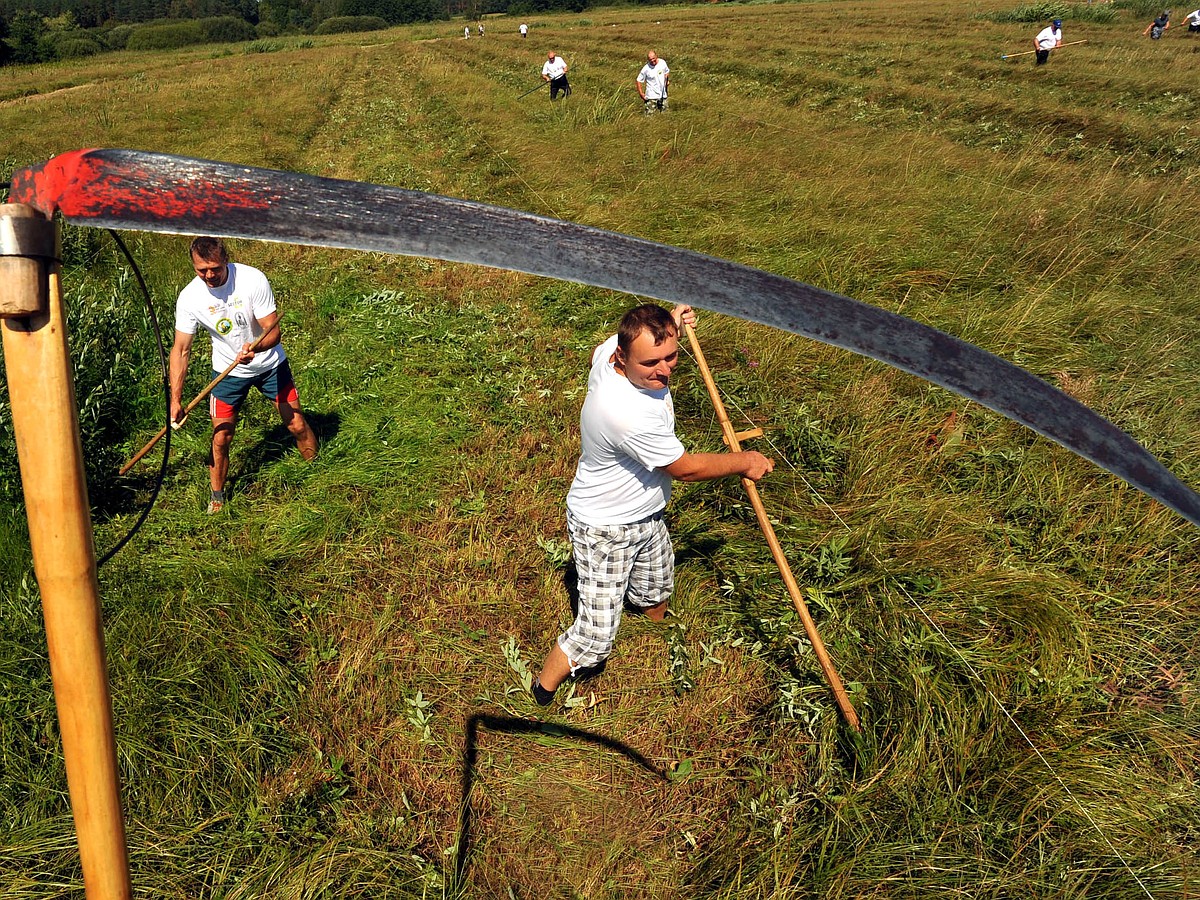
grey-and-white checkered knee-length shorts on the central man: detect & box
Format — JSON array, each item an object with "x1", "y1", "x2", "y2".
[{"x1": 558, "y1": 511, "x2": 674, "y2": 672}]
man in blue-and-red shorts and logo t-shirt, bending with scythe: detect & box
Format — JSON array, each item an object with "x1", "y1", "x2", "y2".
[{"x1": 169, "y1": 238, "x2": 317, "y2": 514}]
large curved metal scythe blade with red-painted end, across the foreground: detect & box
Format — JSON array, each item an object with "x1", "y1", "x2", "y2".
[{"x1": 10, "y1": 150, "x2": 1200, "y2": 524}]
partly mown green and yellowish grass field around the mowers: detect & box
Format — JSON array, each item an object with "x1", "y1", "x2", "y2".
[{"x1": 0, "y1": 0, "x2": 1200, "y2": 900}]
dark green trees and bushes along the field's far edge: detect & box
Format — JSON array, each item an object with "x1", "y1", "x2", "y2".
[{"x1": 0, "y1": 0, "x2": 596, "y2": 65}]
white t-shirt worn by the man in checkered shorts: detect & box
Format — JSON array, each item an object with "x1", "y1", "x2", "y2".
[{"x1": 566, "y1": 335, "x2": 684, "y2": 526}]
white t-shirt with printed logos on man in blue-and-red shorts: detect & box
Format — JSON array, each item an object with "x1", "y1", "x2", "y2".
[{"x1": 175, "y1": 263, "x2": 287, "y2": 378}]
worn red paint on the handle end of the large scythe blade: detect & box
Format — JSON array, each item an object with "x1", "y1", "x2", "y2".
[{"x1": 11, "y1": 150, "x2": 270, "y2": 222}]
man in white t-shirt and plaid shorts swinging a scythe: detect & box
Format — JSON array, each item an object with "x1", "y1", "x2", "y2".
[{"x1": 533, "y1": 304, "x2": 774, "y2": 706}]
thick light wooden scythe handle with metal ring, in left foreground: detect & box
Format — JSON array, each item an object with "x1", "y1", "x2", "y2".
[{"x1": 0, "y1": 204, "x2": 131, "y2": 900}]
